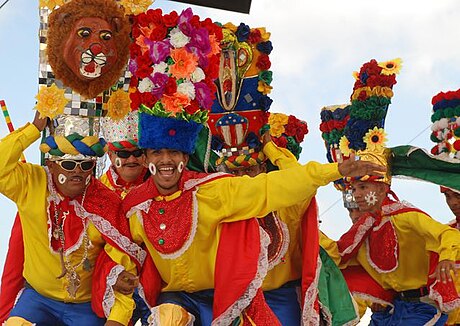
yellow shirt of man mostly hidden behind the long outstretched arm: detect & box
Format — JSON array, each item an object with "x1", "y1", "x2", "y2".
[{"x1": 262, "y1": 142, "x2": 310, "y2": 291}]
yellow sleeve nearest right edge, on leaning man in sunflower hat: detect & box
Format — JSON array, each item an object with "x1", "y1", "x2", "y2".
[{"x1": 394, "y1": 212, "x2": 460, "y2": 261}]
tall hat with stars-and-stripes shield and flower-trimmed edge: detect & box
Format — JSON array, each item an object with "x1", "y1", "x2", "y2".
[{"x1": 209, "y1": 23, "x2": 273, "y2": 169}]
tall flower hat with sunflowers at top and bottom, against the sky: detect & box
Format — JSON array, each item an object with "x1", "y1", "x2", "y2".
[{"x1": 339, "y1": 59, "x2": 401, "y2": 184}]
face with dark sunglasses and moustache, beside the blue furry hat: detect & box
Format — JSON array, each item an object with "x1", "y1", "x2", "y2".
[{"x1": 109, "y1": 147, "x2": 145, "y2": 182}]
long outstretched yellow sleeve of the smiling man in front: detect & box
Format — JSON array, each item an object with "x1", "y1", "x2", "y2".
[{"x1": 206, "y1": 162, "x2": 341, "y2": 222}]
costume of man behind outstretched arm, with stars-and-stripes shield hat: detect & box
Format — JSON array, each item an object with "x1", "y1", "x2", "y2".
[{"x1": 209, "y1": 23, "x2": 356, "y2": 325}]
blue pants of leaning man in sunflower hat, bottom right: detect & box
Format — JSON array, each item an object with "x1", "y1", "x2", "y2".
[{"x1": 369, "y1": 299, "x2": 447, "y2": 326}]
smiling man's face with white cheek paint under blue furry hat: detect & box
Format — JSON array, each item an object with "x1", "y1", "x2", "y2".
[{"x1": 145, "y1": 149, "x2": 189, "y2": 195}]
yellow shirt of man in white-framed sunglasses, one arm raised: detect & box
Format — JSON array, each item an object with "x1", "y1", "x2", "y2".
[{"x1": 0, "y1": 124, "x2": 136, "y2": 325}]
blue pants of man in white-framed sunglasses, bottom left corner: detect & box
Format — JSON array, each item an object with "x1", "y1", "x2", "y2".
[{"x1": 10, "y1": 288, "x2": 105, "y2": 326}]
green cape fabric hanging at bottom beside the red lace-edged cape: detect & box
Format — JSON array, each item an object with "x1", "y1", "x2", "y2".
[{"x1": 318, "y1": 248, "x2": 358, "y2": 326}]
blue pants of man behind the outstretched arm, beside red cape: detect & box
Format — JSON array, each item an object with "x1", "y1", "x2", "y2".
[{"x1": 264, "y1": 282, "x2": 300, "y2": 326}]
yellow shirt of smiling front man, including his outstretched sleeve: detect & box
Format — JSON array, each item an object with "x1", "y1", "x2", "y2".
[{"x1": 130, "y1": 158, "x2": 341, "y2": 292}]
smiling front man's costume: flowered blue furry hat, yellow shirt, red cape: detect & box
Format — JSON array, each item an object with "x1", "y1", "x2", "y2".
[{"x1": 113, "y1": 9, "x2": 350, "y2": 325}]
